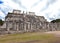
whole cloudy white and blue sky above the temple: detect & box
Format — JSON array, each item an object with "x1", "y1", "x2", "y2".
[{"x1": 0, "y1": 0, "x2": 60, "y2": 21}]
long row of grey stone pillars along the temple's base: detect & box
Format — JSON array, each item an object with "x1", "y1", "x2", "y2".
[{"x1": 6, "y1": 22, "x2": 60, "y2": 31}]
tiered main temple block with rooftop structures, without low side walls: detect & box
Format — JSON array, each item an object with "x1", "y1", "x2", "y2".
[{"x1": 5, "y1": 10, "x2": 47, "y2": 31}]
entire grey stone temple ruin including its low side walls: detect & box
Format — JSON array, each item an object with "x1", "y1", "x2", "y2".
[{"x1": 0, "y1": 10, "x2": 60, "y2": 34}]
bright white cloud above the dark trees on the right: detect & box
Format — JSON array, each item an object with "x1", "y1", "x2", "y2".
[{"x1": 42, "y1": 0, "x2": 60, "y2": 19}]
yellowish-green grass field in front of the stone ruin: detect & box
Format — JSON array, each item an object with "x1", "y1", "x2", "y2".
[{"x1": 0, "y1": 32, "x2": 60, "y2": 43}]
